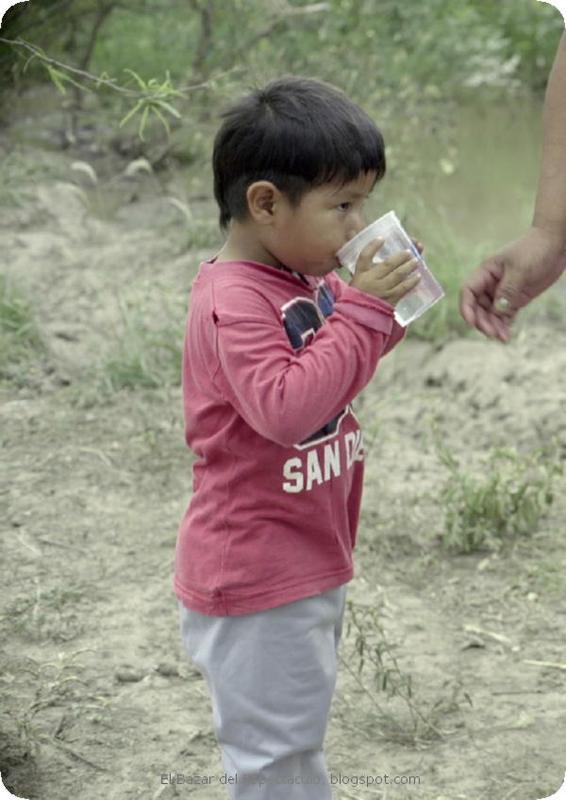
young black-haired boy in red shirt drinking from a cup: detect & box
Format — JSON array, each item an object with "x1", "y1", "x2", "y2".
[{"x1": 174, "y1": 78, "x2": 424, "y2": 800}]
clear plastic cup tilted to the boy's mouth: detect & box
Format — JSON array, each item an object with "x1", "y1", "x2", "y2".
[{"x1": 336, "y1": 211, "x2": 444, "y2": 328}]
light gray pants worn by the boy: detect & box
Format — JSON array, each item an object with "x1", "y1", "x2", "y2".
[{"x1": 179, "y1": 584, "x2": 347, "y2": 800}]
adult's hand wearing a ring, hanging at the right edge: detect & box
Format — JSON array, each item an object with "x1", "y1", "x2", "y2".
[{"x1": 460, "y1": 226, "x2": 566, "y2": 342}]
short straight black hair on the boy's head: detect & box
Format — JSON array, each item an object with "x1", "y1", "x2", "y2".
[{"x1": 212, "y1": 77, "x2": 385, "y2": 228}]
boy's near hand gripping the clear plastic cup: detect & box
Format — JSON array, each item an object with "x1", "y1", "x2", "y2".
[{"x1": 350, "y1": 239, "x2": 423, "y2": 306}]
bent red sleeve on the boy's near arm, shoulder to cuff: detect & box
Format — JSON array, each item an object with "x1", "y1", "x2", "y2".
[{"x1": 213, "y1": 276, "x2": 403, "y2": 446}]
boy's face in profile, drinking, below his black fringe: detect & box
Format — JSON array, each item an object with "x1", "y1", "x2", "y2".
[{"x1": 264, "y1": 172, "x2": 376, "y2": 275}]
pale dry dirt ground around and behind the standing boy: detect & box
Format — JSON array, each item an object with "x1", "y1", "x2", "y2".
[{"x1": 0, "y1": 141, "x2": 566, "y2": 800}]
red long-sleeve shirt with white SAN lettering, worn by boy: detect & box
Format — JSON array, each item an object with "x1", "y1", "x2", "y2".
[{"x1": 174, "y1": 261, "x2": 405, "y2": 616}]
